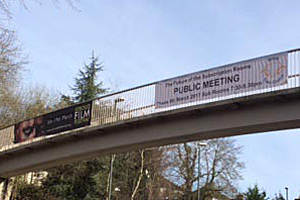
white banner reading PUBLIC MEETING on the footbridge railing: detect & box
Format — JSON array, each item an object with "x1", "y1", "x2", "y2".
[{"x1": 155, "y1": 53, "x2": 288, "y2": 108}]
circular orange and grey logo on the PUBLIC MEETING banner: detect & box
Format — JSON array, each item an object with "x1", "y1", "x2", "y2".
[{"x1": 261, "y1": 60, "x2": 286, "y2": 84}]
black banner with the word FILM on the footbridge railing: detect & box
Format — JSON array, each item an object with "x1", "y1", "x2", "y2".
[{"x1": 14, "y1": 101, "x2": 92, "y2": 143}]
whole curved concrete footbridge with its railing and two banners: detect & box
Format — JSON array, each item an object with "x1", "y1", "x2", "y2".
[{"x1": 0, "y1": 49, "x2": 300, "y2": 178}]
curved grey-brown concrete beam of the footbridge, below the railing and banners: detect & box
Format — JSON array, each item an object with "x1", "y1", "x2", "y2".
[{"x1": 0, "y1": 89, "x2": 300, "y2": 178}]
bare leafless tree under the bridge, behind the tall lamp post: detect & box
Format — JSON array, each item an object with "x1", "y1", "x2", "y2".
[{"x1": 166, "y1": 138, "x2": 244, "y2": 199}]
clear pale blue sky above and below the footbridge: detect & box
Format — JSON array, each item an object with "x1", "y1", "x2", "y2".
[{"x1": 8, "y1": 0, "x2": 300, "y2": 199}]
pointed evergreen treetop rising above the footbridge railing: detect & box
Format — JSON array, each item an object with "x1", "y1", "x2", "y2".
[{"x1": 71, "y1": 52, "x2": 107, "y2": 103}]
